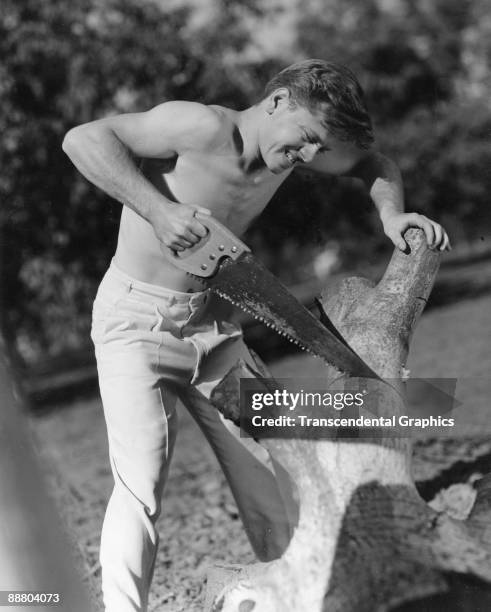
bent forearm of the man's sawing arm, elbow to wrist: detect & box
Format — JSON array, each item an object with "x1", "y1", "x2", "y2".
[{"x1": 63, "y1": 124, "x2": 171, "y2": 221}]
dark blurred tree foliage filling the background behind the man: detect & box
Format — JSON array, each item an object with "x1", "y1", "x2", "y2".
[{"x1": 0, "y1": 0, "x2": 491, "y2": 361}]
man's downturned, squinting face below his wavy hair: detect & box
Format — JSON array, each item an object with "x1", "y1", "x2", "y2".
[{"x1": 259, "y1": 97, "x2": 359, "y2": 174}]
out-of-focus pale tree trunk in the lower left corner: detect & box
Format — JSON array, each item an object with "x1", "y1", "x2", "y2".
[{"x1": 0, "y1": 335, "x2": 91, "y2": 612}]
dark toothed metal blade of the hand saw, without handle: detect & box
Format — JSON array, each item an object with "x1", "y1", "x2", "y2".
[{"x1": 205, "y1": 252, "x2": 379, "y2": 378}]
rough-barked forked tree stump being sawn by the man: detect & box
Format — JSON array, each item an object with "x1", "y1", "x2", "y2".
[{"x1": 206, "y1": 230, "x2": 491, "y2": 612}]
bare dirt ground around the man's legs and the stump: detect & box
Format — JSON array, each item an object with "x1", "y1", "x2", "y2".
[{"x1": 31, "y1": 295, "x2": 491, "y2": 612}]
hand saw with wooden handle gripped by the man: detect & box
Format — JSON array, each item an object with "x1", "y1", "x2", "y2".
[{"x1": 165, "y1": 213, "x2": 379, "y2": 378}]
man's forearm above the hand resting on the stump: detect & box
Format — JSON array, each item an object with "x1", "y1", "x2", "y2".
[{"x1": 357, "y1": 153, "x2": 404, "y2": 223}]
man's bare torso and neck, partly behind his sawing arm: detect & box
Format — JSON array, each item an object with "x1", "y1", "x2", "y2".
[{"x1": 115, "y1": 106, "x2": 290, "y2": 292}]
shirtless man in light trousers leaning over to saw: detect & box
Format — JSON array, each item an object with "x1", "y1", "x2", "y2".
[{"x1": 63, "y1": 60, "x2": 450, "y2": 612}]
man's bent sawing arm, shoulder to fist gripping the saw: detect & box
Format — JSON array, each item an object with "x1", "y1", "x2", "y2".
[{"x1": 63, "y1": 102, "x2": 219, "y2": 250}]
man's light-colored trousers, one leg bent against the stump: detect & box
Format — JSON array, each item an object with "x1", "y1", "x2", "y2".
[{"x1": 91, "y1": 263, "x2": 297, "y2": 612}]
